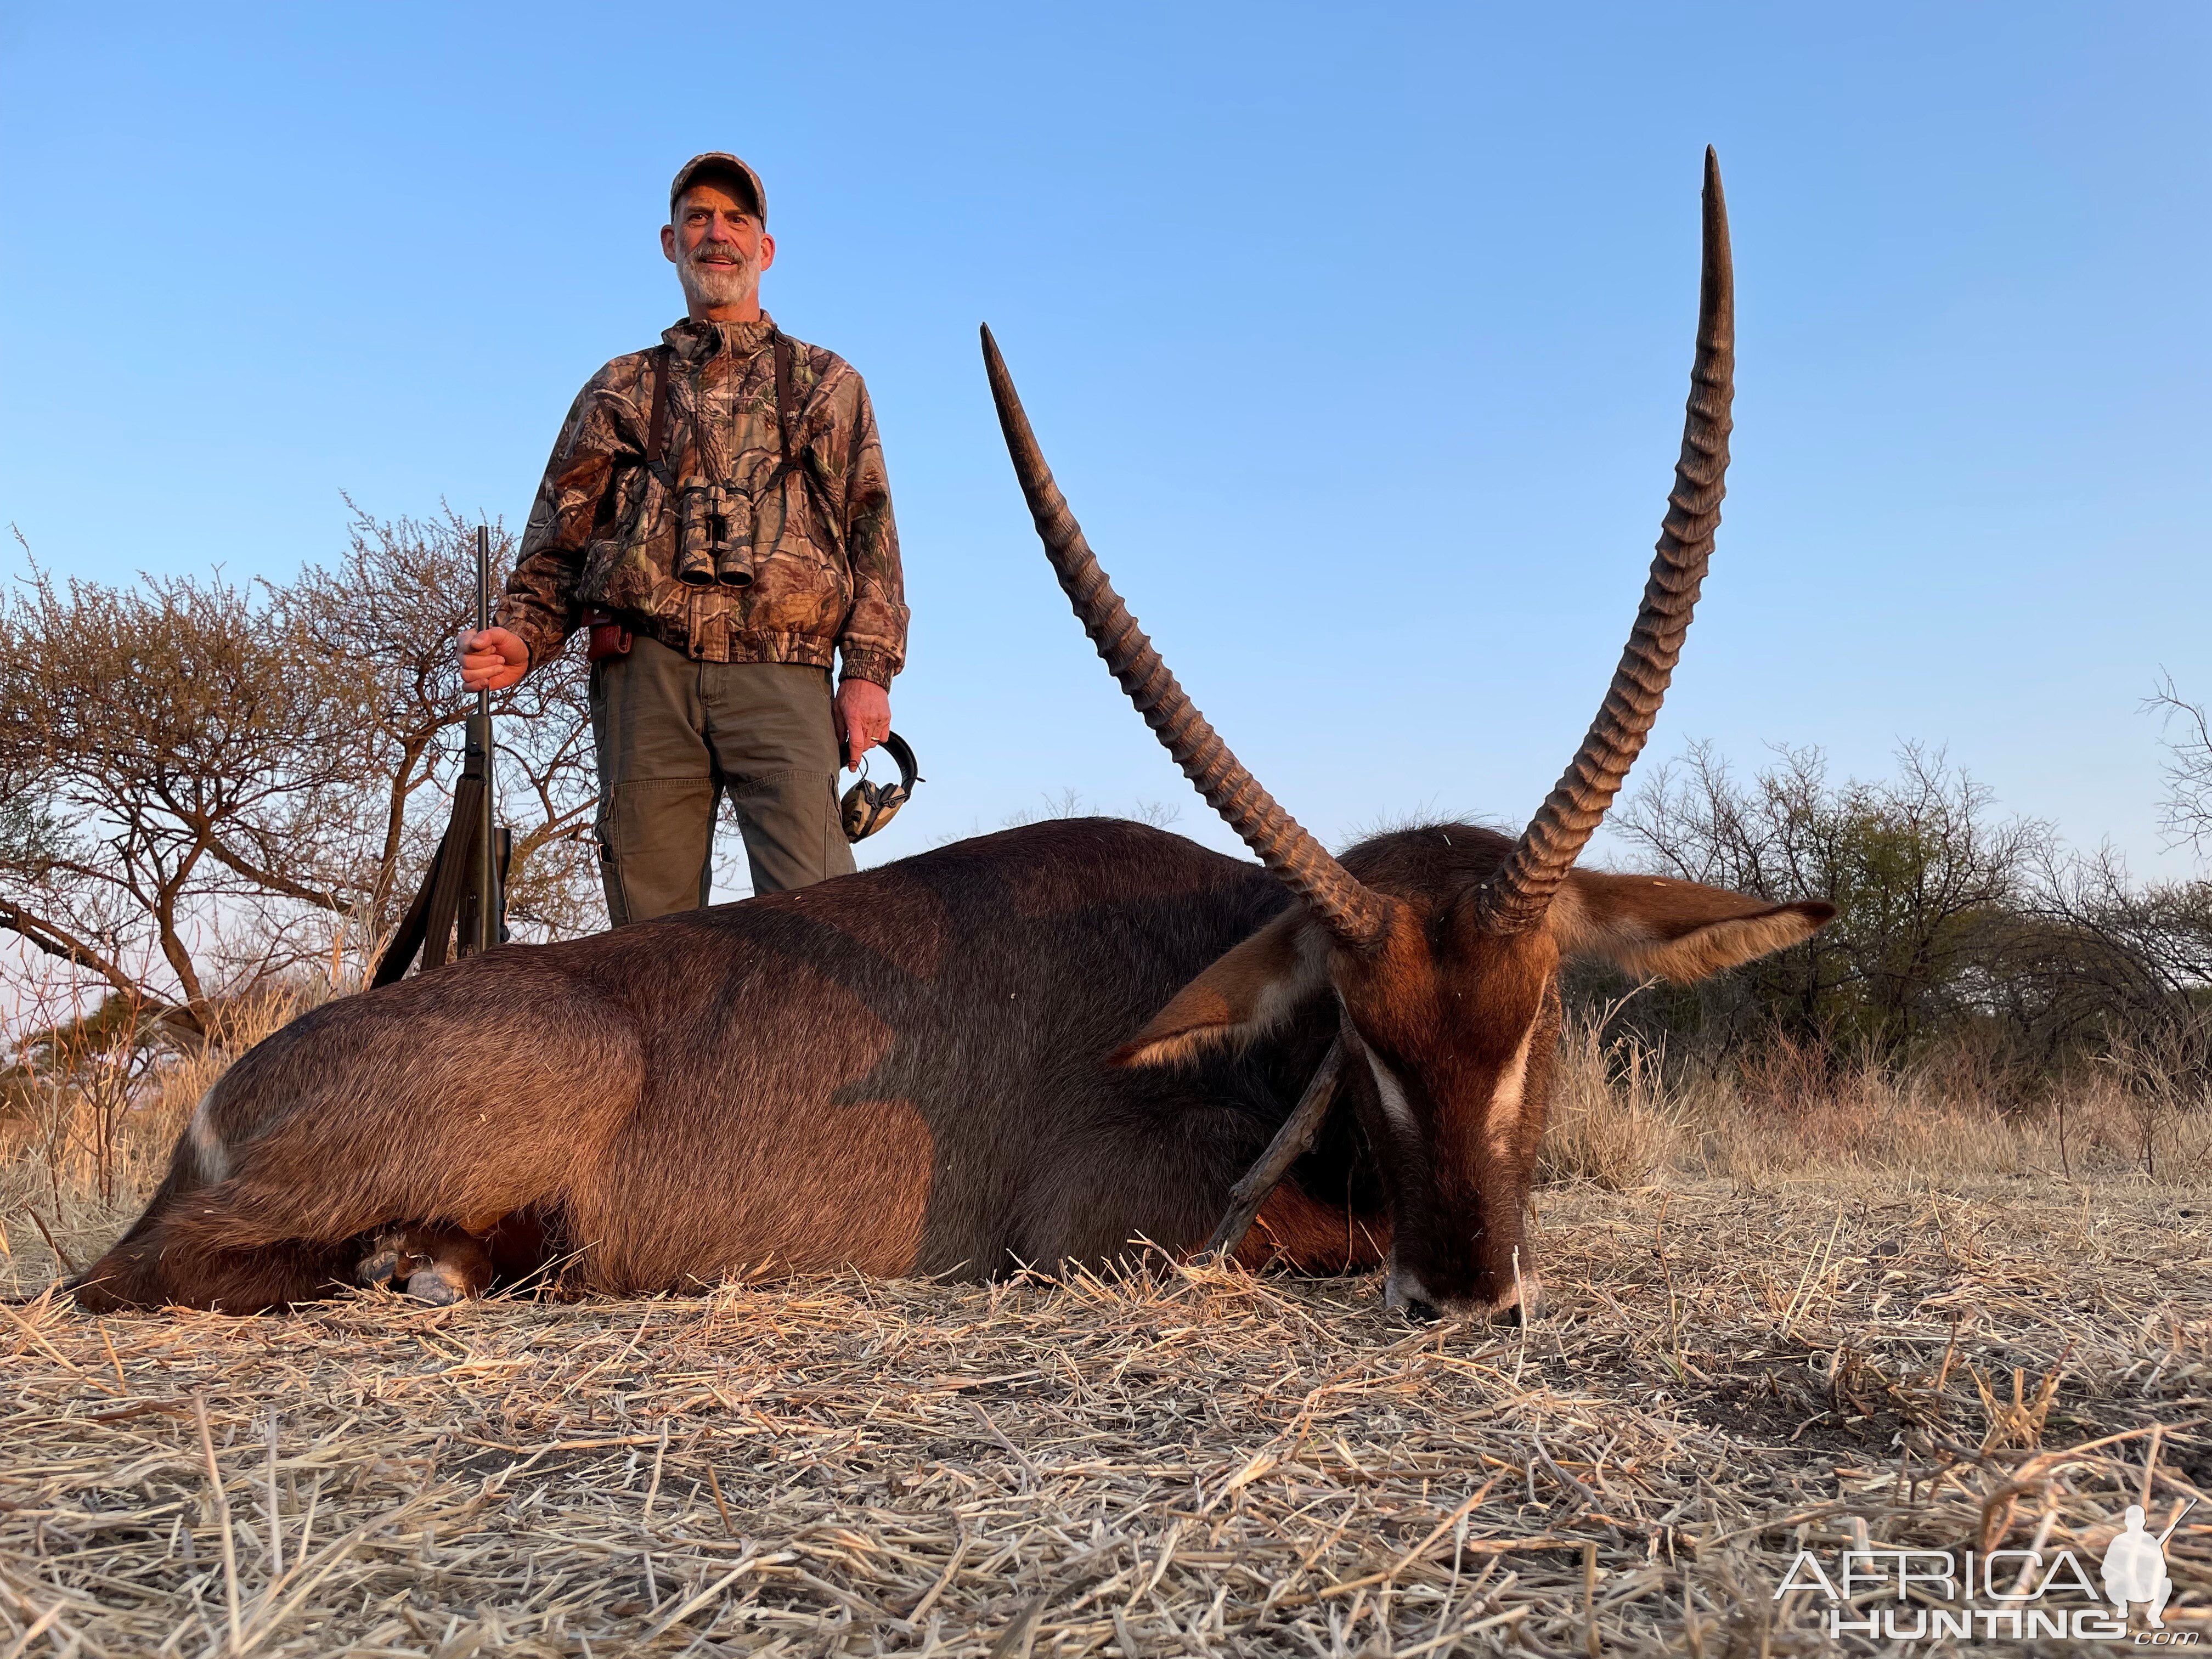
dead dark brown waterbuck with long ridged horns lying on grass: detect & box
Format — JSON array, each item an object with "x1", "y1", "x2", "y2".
[{"x1": 75, "y1": 153, "x2": 1831, "y2": 1316}]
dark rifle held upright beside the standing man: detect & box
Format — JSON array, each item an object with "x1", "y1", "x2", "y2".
[{"x1": 369, "y1": 524, "x2": 515, "y2": 984}]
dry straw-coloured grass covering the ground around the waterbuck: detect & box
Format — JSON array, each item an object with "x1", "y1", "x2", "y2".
[{"x1": 0, "y1": 1022, "x2": 2212, "y2": 1659}]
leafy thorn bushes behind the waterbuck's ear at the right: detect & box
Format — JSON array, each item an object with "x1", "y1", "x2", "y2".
[{"x1": 1590, "y1": 746, "x2": 2212, "y2": 1077}]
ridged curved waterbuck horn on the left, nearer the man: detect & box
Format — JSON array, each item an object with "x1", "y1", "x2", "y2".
[{"x1": 982, "y1": 328, "x2": 1389, "y2": 949}]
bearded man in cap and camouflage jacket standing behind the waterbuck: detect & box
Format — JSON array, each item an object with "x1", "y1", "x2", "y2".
[{"x1": 460, "y1": 153, "x2": 907, "y2": 927}]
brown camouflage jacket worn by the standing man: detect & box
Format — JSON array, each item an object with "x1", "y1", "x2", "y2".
[{"x1": 498, "y1": 317, "x2": 907, "y2": 686}]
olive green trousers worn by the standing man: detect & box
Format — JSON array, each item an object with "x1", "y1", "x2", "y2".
[{"x1": 591, "y1": 635, "x2": 854, "y2": 927}]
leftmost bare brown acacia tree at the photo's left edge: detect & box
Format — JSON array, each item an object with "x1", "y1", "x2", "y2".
[{"x1": 0, "y1": 566, "x2": 354, "y2": 1033}]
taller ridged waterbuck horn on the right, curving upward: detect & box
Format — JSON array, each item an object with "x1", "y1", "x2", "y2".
[{"x1": 1482, "y1": 148, "x2": 1736, "y2": 934}]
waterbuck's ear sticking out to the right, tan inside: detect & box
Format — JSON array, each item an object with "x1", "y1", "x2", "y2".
[{"x1": 1550, "y1": 870, "x2": 1836, "y2": 980}]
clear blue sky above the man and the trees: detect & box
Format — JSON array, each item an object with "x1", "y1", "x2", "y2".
[{"x1": 0, "y1": 4, "x2": 2212, "y2": 889}]
